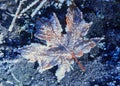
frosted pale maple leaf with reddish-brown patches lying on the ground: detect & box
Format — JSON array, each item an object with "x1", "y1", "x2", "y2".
[{"x1": 19, "y1": 7, "x2": 101, "y2": 82}]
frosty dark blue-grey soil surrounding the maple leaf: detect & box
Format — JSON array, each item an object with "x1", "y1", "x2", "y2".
[{"x1": 0, "y1": 0, "x2": 120, "y2": 86}]
